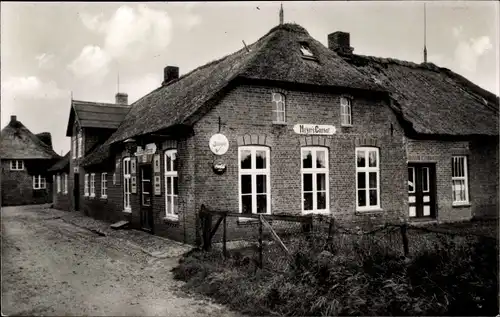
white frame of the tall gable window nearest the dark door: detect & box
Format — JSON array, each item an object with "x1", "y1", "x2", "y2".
[{"x1": 354, "y1": 147, "x2": 380, "y2": 211}]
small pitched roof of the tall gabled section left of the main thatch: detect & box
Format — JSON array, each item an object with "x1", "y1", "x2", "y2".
[{"x1": 66, "y1": 100, "x2": 130, "y2": 136}]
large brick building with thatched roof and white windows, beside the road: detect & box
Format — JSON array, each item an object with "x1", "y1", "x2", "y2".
[{"x1": 64, "y1": 24, "x2": 498, "y2": 243}]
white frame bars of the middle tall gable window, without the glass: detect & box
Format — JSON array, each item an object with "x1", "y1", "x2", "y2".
[{"x1": 300, "y1": 146, "x2": 330, "y2": 214}]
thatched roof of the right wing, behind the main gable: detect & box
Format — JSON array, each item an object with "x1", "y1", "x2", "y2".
[{"x1": 341, "y1": 54, "x2": 499, "y2": 136}]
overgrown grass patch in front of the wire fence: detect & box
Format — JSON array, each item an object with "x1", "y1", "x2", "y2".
[{"x1": 173, "y1": 226, "x2": 498, "y2": 316}]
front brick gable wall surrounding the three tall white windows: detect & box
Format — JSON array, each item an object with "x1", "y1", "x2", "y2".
[{"x1": 188, "y1": 82, "x2": 407, "y2": 241}]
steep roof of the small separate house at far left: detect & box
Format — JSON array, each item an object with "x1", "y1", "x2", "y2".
[{"x1": 0, "y1": 119, "x2": 60, "y2": 159}]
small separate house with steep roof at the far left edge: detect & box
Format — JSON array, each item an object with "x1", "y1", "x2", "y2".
[{"x1": 0, "y1": 116, "x2": 60, "y2": 206}]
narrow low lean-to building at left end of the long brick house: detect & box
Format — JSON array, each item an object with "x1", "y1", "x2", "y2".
[{"x1": 48, "y1": 151, "x2": 72, "y2": 211}]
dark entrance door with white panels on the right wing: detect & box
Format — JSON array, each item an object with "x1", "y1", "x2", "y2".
[{"x1": 408, "y1": 164, "x2": 436, "y2": 218}]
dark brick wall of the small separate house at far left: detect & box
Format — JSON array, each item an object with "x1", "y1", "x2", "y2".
[{"x1": 1, "y1": 160, "x2": 52, "y2": 206}]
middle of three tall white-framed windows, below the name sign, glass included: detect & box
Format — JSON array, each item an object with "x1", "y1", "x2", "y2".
[{"x1": 301, "y1": 147, "x2": 329, "y2": 213}]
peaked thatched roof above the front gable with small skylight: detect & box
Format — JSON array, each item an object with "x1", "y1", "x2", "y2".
[{"x1": 106, "y1": 24, "x2": 383, "y2": 144}]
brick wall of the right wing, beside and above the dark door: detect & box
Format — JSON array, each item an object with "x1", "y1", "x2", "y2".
[{"x1": 407, "y1": 139, "x2": 498, "y2": 221}]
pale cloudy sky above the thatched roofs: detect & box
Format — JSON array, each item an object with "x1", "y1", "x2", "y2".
[{"x1": 1, "y1": 1, "x2": 500, "y2": 155}]
